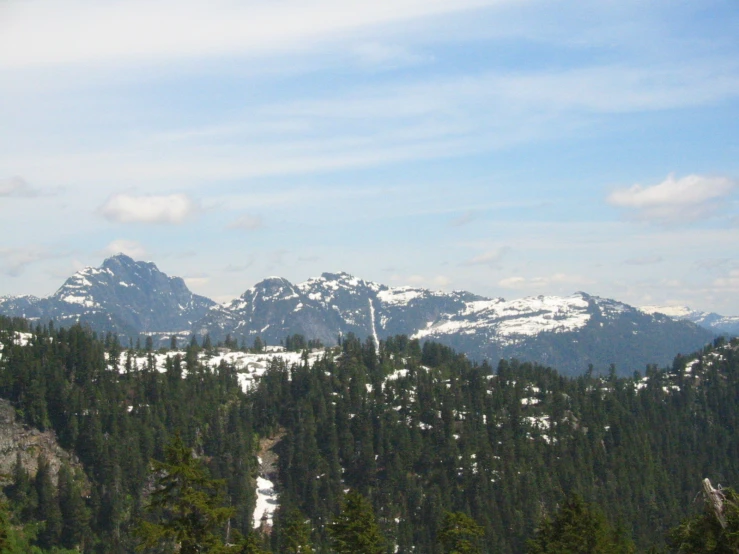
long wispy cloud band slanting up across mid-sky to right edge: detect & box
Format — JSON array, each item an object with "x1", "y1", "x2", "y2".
[{"x1": 5, "y1": 60, "x2": 739, "y2": 185}]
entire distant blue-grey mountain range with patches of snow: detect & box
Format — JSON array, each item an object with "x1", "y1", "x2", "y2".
[{"x1": 0, "y1": 254, "x2": 720, "y2": 373}]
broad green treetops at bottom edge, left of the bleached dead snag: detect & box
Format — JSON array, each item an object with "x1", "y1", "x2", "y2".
[{"x1": 528, "y1": 495, "x2": 634, "y2": 554}]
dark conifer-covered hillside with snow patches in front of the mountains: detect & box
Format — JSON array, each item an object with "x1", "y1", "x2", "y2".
[{"x1": 0, "y1": 312, "x2": 739, "y2": 553}]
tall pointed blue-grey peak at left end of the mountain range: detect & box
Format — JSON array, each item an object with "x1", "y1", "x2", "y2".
[{"x1": 0, "y1": 254, "x2": 215, "y2": 336}]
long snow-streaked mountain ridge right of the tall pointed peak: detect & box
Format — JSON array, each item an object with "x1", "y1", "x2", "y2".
[{"x1": 195, "y1": 273, "x2": 714, "y2": 374}]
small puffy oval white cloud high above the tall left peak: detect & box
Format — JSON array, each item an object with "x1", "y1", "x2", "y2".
[{"x1": 98, "y1": 194, "x2": 198, "y2": 224}]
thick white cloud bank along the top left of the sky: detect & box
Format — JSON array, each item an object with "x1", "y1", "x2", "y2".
[{"x1": 0, "y1": 0, "x2": 507, "y2": 67}]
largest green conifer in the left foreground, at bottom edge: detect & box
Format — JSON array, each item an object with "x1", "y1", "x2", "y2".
[{"x1": 136, "y1": 435, "x2": 234, "y2": 554}]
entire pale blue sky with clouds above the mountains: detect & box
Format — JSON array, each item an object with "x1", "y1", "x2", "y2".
[{"x1": 0, "y1": 0, "x2": 739, "y2": 315}]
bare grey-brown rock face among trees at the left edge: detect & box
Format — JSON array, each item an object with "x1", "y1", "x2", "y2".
[{"x1": 0, "y1": 399, "x2": 79, "y2": 486}]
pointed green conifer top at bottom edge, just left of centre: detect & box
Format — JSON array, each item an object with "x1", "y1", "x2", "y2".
[{"x1": 328, "y1": 491, "x2": 385, "y2": 554}]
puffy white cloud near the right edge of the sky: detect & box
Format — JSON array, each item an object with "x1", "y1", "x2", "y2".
[{"x1": 607, "y1": 175, "x2": 736, "y2": 223}]
